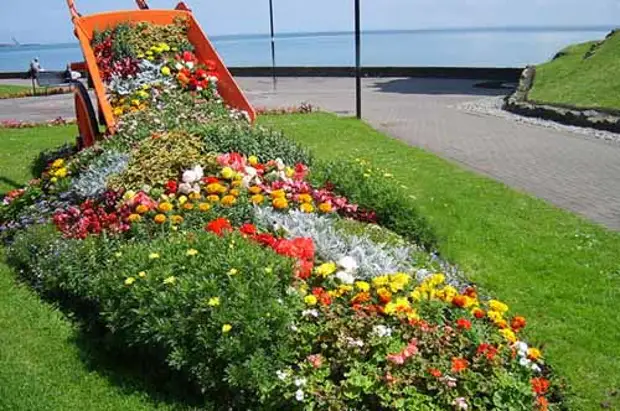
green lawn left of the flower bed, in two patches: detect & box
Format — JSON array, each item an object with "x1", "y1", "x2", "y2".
[{"x1": 0, "y1": 126, "x2": 189, "y2": 411}]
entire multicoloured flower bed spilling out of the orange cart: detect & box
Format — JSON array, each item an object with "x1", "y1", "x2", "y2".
[{"x1": 0, "y1": 17, "x2": 562, "y2": 410}]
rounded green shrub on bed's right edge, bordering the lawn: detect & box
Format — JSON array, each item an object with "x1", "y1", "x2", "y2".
[{"x1": 311, "y1": 161, "x2": 436, "y2": 249}]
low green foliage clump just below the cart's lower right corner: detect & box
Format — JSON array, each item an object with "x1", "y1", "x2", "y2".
[{"x1": 190, "y1": 121, "x2": 312, "y2": 165}]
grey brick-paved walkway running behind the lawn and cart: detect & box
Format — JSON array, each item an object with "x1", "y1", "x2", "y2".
[{"x1": 0, "y1": 78, "x2": 620, "y2": 230}]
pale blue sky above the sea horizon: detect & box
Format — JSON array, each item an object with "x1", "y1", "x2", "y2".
[{"x1": 0, "y1": 0, "x2": 620, "y2": 43}]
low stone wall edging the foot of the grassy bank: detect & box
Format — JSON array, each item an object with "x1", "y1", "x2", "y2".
[{"x1": 503, "y1": 66, "x2": 620, "y2": 133}]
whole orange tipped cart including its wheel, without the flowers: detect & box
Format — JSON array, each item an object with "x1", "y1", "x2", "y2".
[{"x1": 67, "y1": 0, "x2": 256, "y2": 147}]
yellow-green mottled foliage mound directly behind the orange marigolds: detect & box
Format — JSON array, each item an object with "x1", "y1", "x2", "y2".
[{"x1": 109, "y1": 132, "x2": 215, "y2": 189}]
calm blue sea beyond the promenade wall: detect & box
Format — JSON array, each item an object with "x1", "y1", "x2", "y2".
[{"x1": 0, "y1": 26, "x2": 613, "y2": 72}]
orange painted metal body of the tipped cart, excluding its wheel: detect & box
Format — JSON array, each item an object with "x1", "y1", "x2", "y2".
[{"x1": 67, "y1": 0, "x2": 256, "y2": 139}]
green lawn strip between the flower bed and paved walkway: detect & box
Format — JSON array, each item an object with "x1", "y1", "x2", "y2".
[{"x1": 261, "y1": 114, "x2": 620, "y2": 410}]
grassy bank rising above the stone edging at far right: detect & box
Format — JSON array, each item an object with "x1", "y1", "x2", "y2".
[{"x1": 529, "y1": 32, "x2": 620, "y2": 110}]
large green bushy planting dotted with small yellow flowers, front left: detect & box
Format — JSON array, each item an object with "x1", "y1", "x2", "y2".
[{"x1": 8, "y1": 227, "x2": 300, "y2": 409}]
